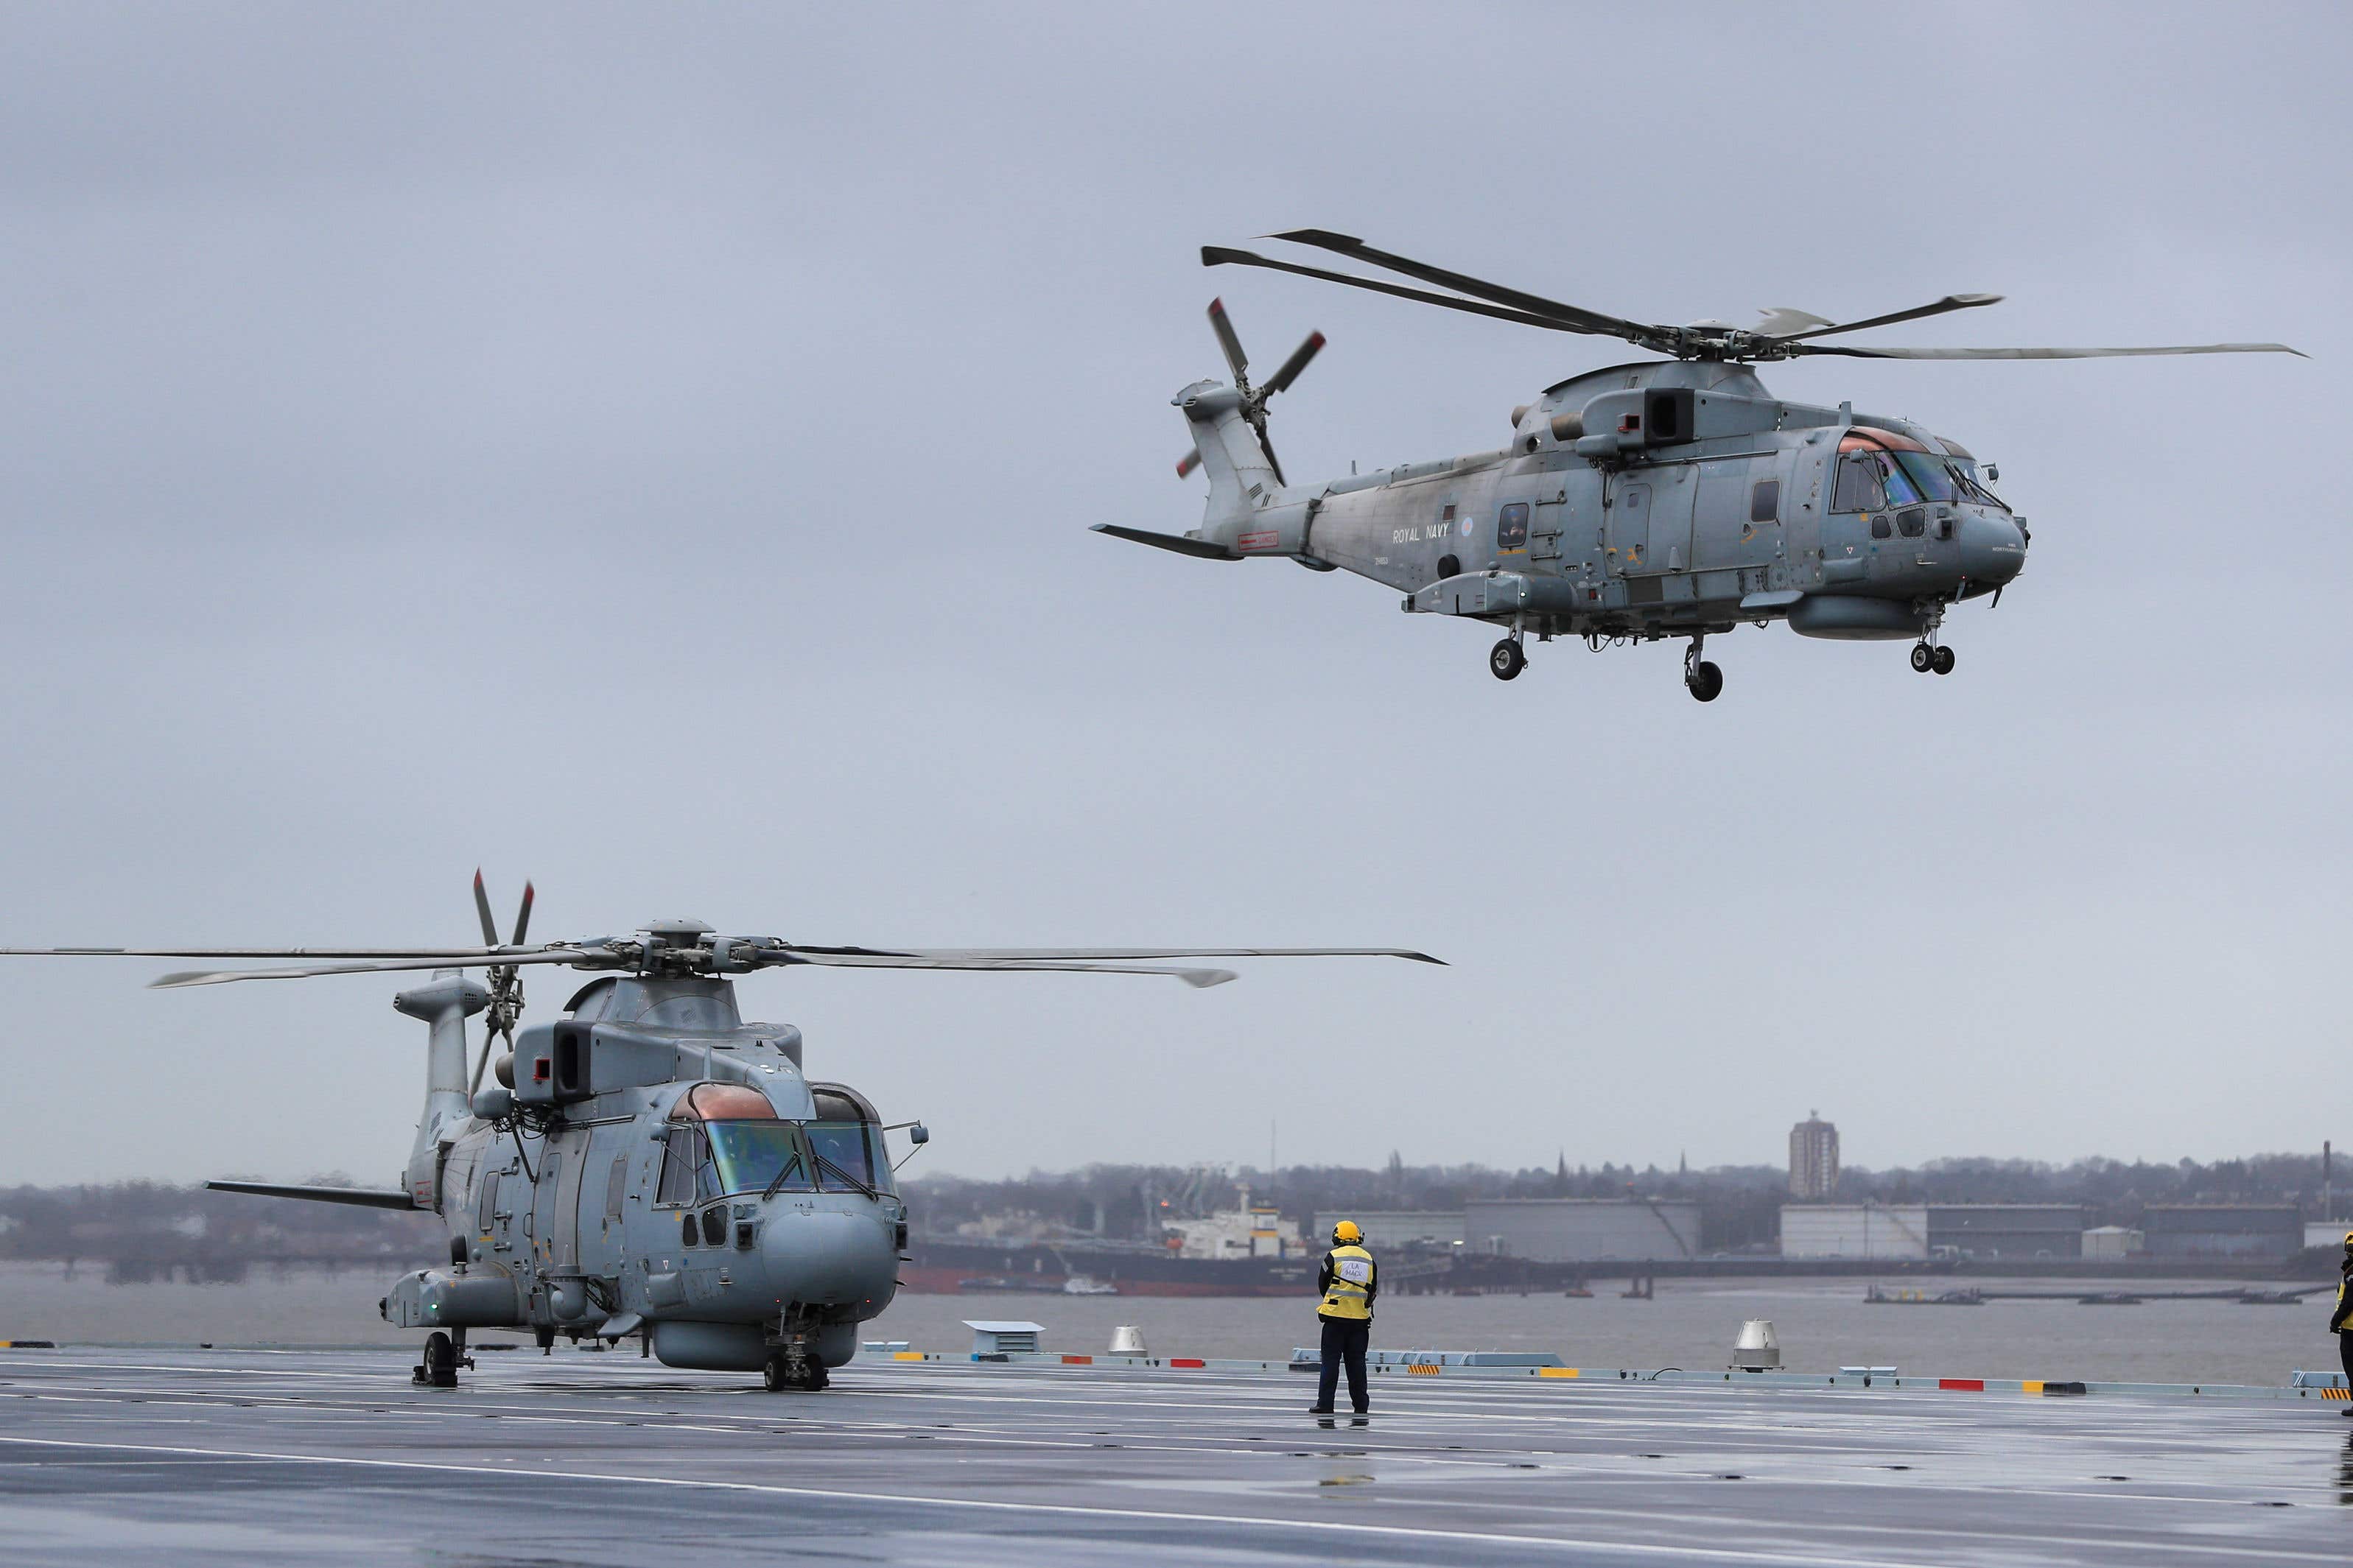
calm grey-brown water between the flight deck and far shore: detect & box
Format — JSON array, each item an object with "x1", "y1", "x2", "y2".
[{"x1": 0, "y1": 1265, "x2": 2337, "y2": 1382}]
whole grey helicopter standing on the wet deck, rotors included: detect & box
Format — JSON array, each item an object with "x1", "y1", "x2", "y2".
[{"x1": 0, "y1": 872, "x2": 1440, "y2": 1392}]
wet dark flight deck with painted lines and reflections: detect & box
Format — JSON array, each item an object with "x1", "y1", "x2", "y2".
[{"x1": 0, "y1": 1349, "x2": 2353, "y2": 1568}]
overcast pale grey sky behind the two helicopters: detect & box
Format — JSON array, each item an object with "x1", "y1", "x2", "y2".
[{"x1": 0, "y1": 4, "x2": 2353, "y2": 1180}]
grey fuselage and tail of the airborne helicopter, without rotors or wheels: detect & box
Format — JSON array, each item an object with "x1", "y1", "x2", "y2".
[{"x1": 1176, "y1": 359, "x2": 2026, "y2": 637}]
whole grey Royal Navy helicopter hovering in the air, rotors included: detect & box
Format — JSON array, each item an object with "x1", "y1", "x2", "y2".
[{"x1": 1094, "y1": 228, "x2": 2299, "y2": 703}]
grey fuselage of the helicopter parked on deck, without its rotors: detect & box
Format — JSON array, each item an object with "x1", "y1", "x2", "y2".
[{"x1": 384, "y1": 976, "x2": 906, "y2": 1371}]
